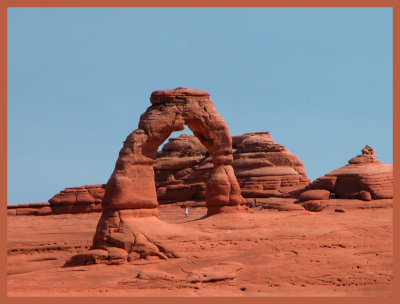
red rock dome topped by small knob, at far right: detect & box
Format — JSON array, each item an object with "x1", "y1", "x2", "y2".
[{"x1": 308, "y1": 146, "x2": 393, "y2": 200}]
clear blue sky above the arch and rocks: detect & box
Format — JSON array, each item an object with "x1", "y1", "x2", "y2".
[{"x1": 8, "y1": 8, "x2": 393, "y2": 204}]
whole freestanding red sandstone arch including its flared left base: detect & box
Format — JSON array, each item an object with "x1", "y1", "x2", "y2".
[{"x1": 65, "y1": 88, "x2": 245, "y2": 266}]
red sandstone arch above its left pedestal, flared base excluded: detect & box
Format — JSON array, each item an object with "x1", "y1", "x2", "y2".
[{"x1": 102, "y1": 88, "x2": 245, "y2": 215}]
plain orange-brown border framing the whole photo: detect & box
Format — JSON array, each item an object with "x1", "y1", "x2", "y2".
[{"x1": 0, "y1": 0, "x2": 400, "y2": 304}]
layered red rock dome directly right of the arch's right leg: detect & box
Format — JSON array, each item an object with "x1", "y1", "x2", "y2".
[{"x1": 232, "y1": 132, "x2": 310, "y2": 198}]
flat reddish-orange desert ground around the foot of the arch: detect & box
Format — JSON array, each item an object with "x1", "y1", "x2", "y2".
[{"x1": 7, "y1": 199, "x2": 393, "y2": 297}]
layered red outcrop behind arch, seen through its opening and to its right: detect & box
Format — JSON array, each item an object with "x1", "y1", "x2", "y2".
[{"x1": 154, "y1": 132, "x2": 310, "y2": 203}]
